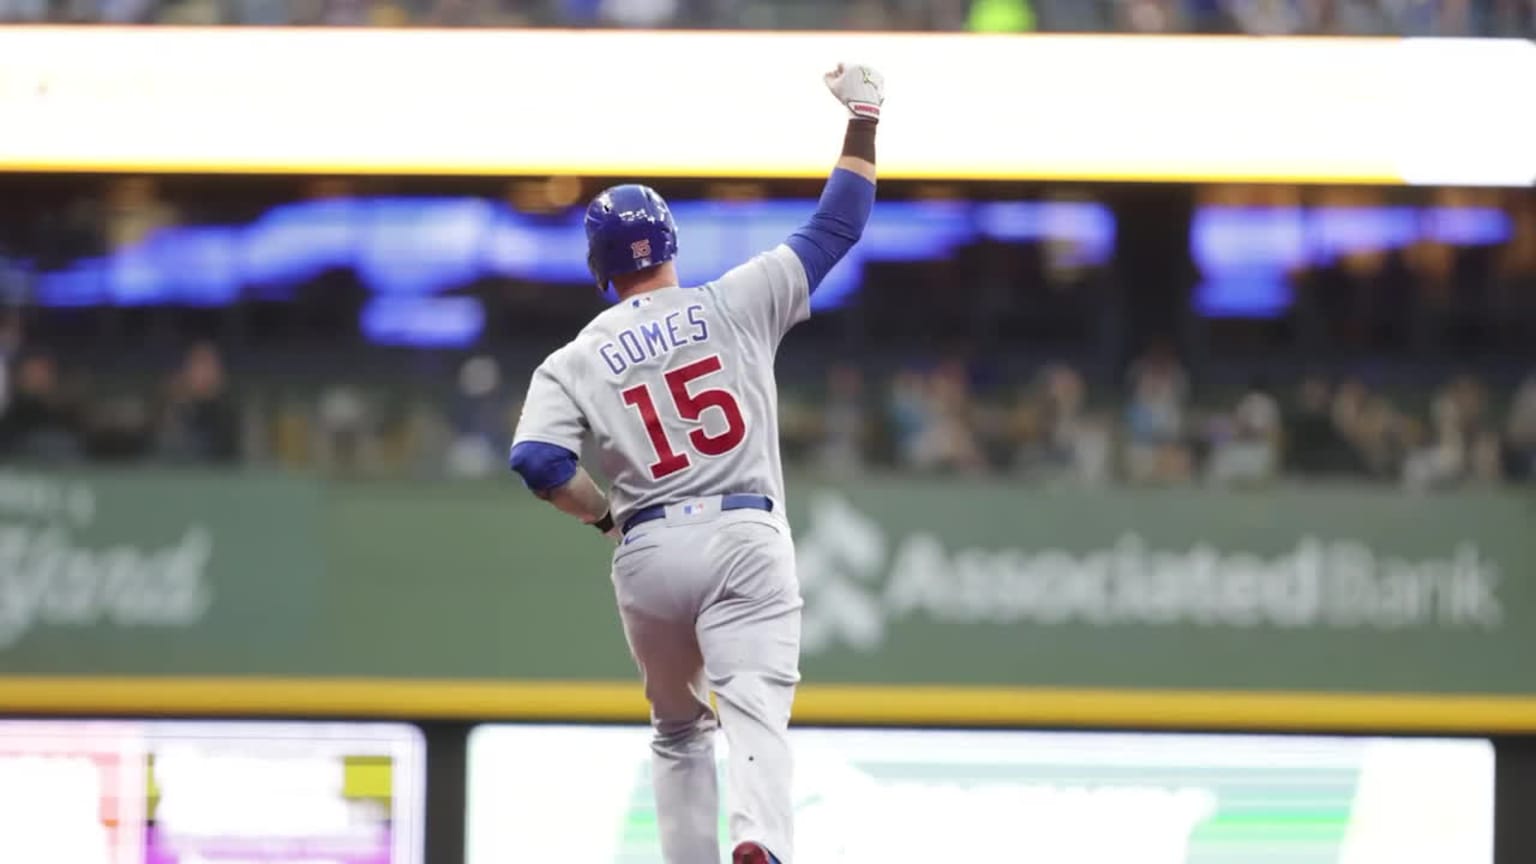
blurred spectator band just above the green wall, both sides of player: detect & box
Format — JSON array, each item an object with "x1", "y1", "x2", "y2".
[{"x1": 0, "y1": 321, "x2": 1536, "y2": 490}]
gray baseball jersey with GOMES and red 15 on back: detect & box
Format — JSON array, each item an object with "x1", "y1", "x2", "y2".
[{"x1": 515, "y1": 244, "x2": 811, "y2": 524}]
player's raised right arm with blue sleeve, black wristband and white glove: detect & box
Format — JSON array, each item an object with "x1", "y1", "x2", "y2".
[{"x1": 785, "y1": 63, "x2": 885, "y2": 292}]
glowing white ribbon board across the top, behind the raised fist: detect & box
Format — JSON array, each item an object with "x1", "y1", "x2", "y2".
[{"x1": 0, "y1": 28, "x2": 1536, "y2": 186}]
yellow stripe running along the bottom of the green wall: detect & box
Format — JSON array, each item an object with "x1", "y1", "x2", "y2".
[{"x1": 0, "y1": 678, "x2": 1536, "y2": 735}]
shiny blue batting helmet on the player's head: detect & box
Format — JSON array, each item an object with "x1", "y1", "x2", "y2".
[{"x1": 587, "y1": 183, "x2": 677, "y2": 295}]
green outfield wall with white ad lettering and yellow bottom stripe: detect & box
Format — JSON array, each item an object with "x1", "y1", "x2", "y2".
[{"x1": 0, "y1": 470, "x2": 1536, "y2": 729}]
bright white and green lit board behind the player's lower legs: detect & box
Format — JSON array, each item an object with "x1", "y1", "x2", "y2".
[{"x1": 465, "y1": 726, "x2": 1495, "y2": 864}]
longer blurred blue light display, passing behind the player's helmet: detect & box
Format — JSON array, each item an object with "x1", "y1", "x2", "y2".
[{"x1": 18, "y1": 198, "x2": 1115, "y2": 346}]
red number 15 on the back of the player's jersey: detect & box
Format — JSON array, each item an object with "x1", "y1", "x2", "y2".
[{"x1": 619, "y1": 354, "x2": 746, "y2": 480}]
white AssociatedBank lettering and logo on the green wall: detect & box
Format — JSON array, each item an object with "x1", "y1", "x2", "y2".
[{"x1": 796, "y1": 493, "x2": 1504, "y2": 655}]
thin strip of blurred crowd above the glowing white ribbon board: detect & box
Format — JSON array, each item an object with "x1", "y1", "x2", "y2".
[{"x1": 0, "y1": 0, "x2": 1536, "y2": 35}]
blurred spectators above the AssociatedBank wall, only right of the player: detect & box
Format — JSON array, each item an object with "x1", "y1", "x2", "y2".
[{"x1": 783, "y1": 347, "x2": 1536, "y2": 490}]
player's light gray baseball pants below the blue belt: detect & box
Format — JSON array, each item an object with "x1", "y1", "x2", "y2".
[{"x1": 613, "y1": 498, "x2": 803, "y2": 864}]
